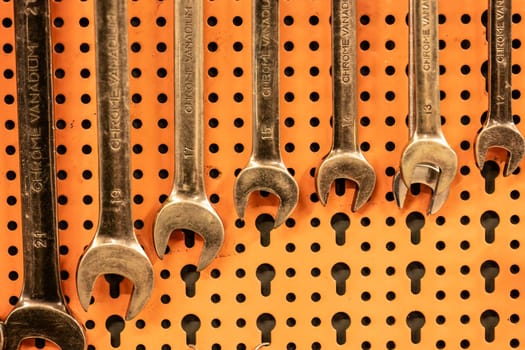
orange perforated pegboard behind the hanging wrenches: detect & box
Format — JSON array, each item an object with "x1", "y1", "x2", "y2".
[{"x1": 0, "y1": 0, "x2": 525, "y2": 350}]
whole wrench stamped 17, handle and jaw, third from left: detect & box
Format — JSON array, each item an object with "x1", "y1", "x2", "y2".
[{"x1": 153, "y1": 0, "x2": 224, "y2": 270}]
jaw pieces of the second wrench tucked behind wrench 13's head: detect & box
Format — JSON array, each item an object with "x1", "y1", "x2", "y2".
[{"x1": 393, "y1": 164, "x2": 449, "y2": 215}]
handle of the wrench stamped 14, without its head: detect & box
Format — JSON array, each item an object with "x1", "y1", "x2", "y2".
[{"x1": 332, "y1": 0, "x2": 358, "y2": 152}]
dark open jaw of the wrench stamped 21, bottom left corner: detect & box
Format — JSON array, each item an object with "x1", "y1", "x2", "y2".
[{"x1": 4, "y1": 299, "x2": 86, "y2": 350}]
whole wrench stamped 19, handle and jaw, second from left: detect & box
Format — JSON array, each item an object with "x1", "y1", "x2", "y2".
[{"x1": 77, "y1": 0, "x2": 153, "y2": 320}]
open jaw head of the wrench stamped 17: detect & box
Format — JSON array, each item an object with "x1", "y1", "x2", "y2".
[{"x1": 153, "y1": 196, "x2": 224, "y2": 271}]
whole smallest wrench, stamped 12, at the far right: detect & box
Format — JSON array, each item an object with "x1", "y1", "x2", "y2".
[{"x1": 474, "y1": 0, "x2": 525, "y2": 176}]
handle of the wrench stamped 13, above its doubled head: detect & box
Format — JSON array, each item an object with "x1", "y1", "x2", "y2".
[{"x1": 409, "y1": 0, "x2": 442, "y2": 137}]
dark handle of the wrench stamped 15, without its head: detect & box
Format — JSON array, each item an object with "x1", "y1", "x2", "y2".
[{"x1": 252, "y1": 0, "x2": 281, "y2": 162}]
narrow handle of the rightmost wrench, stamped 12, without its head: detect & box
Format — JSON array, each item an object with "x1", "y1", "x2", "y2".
[{"x1": 488, "y1": 0, "x2": 513, "y2": 123}]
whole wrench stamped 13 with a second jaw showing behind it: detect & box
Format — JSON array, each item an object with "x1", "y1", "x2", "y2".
[{"x1": 394, "y1": 0, "x2": 458, "y2": 213}]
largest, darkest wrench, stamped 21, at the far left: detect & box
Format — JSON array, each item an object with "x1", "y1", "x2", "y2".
[{"x1": 5, "y1": 0, "x2": 86, "y2": 350}]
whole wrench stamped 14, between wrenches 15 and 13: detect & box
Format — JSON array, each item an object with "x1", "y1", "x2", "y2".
[{"x1": 316, "y1": 0, "x2": 376, "y2": 211}]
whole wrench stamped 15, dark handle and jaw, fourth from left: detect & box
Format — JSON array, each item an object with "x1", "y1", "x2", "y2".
[{"x1": 234, "y1": 0, "x2": 299, "y2": 227}]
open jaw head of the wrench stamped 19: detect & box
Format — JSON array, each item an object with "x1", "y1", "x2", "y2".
[{"x1": 77, "y1": 238, "x2": 154, "y2": 320}]
